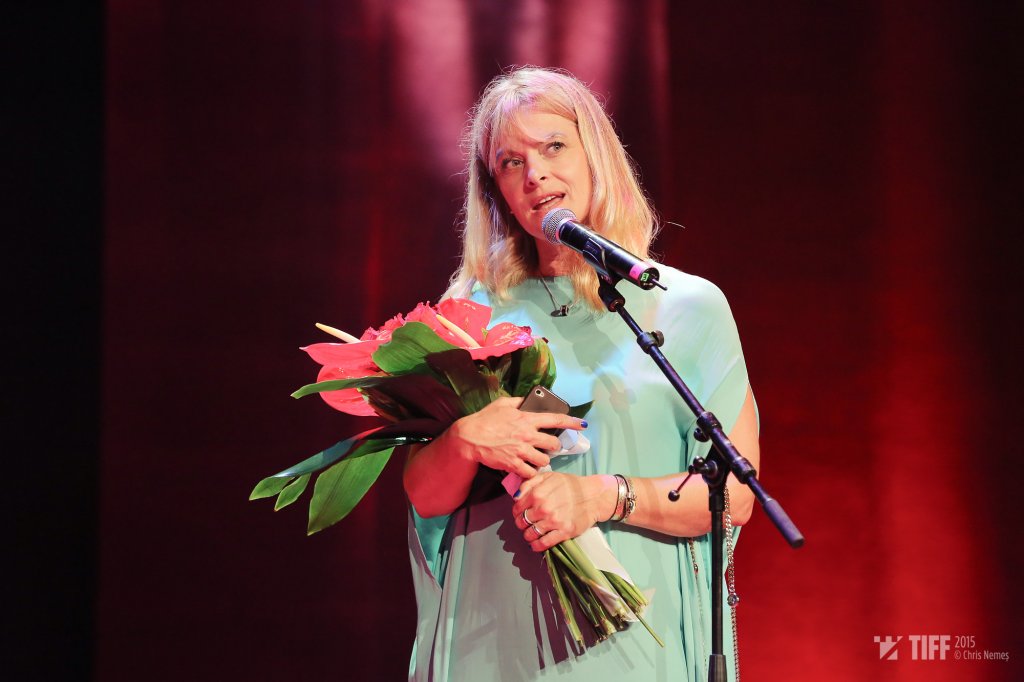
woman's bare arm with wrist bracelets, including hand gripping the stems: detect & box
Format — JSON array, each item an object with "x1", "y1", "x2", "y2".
[{"x1": 512, "y1": 387, "x2": 761, "y2": 551}]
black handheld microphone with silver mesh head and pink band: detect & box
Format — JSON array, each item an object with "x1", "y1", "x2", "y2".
[{"x1": 541, "y1": 209, "x2": 666, "y2": 289}]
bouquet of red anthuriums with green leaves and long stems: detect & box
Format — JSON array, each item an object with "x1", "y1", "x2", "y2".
[{"x1": 249, "y1": 299, "x2": 664, "y2": 647}]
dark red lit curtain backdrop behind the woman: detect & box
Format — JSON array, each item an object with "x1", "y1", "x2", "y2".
[{"x1": 96, "y1": 0, "x2": 1024, "y2": 682}]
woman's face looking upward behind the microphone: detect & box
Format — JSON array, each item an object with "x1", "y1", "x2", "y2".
[{"x1": 495, "y1": 110, "x2": 593, "y2": 244}]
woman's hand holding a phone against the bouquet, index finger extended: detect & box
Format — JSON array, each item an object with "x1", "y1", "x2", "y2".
[{"x1": 443, "y1": 397, "x2": 583, "y2": 479}]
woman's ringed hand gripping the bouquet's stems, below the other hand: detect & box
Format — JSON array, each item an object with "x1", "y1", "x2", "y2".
[{"x1": 512, "y1": 471, "x2": 618, "y2": 552}]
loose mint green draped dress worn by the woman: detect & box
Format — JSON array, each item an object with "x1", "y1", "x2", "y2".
[{"x1": 409, "y1": 265, "x2": 748, "y2": 682}]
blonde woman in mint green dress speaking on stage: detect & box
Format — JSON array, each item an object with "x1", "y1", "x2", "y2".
[{"x1": 404, "y1": 68, "x2": 759, "y2": 682}]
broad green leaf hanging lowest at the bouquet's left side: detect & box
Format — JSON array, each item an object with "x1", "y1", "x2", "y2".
[{"x1": 306, "y1": 443, "x2": 394, "y2": 536}]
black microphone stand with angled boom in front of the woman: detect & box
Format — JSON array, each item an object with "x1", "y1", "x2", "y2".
[{"x1": 598, "y1": 272, "x2": 804, "y2": 682}]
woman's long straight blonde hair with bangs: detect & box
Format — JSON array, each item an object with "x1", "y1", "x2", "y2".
[{"x1": 444, "y1": 67, "x2": 657, "y2": 310}]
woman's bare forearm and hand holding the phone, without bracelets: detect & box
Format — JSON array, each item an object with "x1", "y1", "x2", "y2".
[{"x1": 402, "y1": 398, "x2": 583, "y2": 518}]
